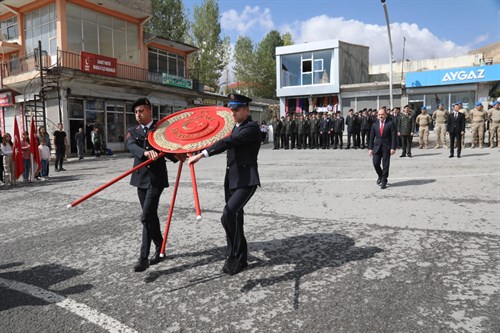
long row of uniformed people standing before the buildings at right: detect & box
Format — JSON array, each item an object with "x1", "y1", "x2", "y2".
[{"x1": 269, "y1": 101, "x2": 500, "y2": 152}]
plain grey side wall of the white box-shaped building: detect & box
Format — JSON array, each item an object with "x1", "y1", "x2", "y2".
[{"x1": 339, "y1": 41, "x2": 369, "y2": 85}]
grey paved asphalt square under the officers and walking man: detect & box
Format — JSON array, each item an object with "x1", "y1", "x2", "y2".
[{"x1": 0, "y1": 144, "x2": 500, "y2": 333}]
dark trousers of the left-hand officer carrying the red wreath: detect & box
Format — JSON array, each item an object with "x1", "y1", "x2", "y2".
[{"x1": 137, "y1": 185, "x2": 163, "y2": 259}]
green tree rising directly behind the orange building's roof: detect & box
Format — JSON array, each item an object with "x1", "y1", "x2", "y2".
[{"x1": 145, "y1": 0, "x2": 189, "y2": 42}]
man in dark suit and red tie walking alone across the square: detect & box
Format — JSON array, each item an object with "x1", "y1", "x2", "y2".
[{"x1": 368, "y1": 109, "x2": 398, "y2": 189}]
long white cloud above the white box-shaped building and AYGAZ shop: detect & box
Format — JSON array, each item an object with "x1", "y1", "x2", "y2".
[{"x1": 280, "y1": 15, "x2": 470, "y2": 64}]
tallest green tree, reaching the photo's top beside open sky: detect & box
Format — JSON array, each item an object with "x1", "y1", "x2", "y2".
[{"x1": 191, "y1": 0, "x2": 229, "y2": 91}]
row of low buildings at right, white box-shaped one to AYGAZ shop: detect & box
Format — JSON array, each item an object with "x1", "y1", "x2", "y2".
[{"x1": 276, "y1": 40, "x2": 500, "y2": 115}]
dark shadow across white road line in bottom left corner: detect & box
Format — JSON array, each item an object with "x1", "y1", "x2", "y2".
[{"x1": 0, "y1": 262, "x2": 92, "y2": 311}]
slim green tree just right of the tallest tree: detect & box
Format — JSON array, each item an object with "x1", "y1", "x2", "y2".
[{"x1": 233, "y1": 36, "x2": 256, "y2": 96}]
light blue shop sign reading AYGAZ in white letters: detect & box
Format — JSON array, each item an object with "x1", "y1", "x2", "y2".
[{"x1": 406, "y1": 65, "x2": 500, "y2": 88}]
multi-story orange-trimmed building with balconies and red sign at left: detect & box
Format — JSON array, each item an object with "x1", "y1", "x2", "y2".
[{"x1": 0, "y1": 0, "x2": 228, "y2": 153}]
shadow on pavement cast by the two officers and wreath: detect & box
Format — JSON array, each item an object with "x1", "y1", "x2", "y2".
[{"x1": 146, "y1": 233, "x2": 383, "y2": 309}]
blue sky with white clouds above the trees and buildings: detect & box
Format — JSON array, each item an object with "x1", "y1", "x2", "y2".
[{"x1": 184, "y1": 0, "x2": 500, "y2": 64}]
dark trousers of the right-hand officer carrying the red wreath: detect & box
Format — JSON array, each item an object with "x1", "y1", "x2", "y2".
[{"x1": 221, "y1": 184, "x2": 257, "y2": 263}]
